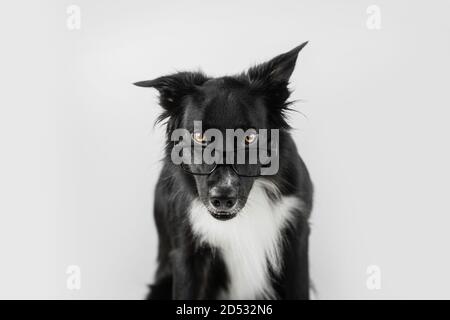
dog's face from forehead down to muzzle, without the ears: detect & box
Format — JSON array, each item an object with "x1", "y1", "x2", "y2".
[{"x1": 181, "y1": 78, "x2": 268, "y2": 220}]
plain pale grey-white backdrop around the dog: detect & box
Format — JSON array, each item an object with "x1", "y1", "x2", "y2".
[{"x1": 0, "y1": 0, "x2": 450, "y2": 299}]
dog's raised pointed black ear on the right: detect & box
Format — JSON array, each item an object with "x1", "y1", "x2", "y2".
[{"x1": 247, "y1": 41, "x2": 308, "y2": 84}]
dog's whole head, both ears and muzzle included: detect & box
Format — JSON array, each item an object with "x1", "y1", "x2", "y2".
[{"x1": 136, "y1": 43, "x2": 306, "y2": 220}]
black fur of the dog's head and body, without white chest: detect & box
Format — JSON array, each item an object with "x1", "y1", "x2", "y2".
[{"x1": 136, "y1": 43, "x2": 313, "y2": 299}]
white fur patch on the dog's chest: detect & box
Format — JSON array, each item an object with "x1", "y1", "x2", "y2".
[{"x1": 190, "y1": 181, "x2": 301, "y2": 299}]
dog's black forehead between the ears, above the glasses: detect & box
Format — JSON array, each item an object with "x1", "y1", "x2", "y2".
[{"x1": 186, "y1": 78, "x2": 266, "y2": 129}]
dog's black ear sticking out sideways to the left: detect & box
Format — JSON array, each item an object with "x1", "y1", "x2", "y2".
[{"x1": 134, "y1": 72, "x2": 208, "y2": 112}]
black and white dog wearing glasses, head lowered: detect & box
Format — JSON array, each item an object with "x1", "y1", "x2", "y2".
[{"x1": 135, "y1": 42, "x2": 313, "y2": 299}]
